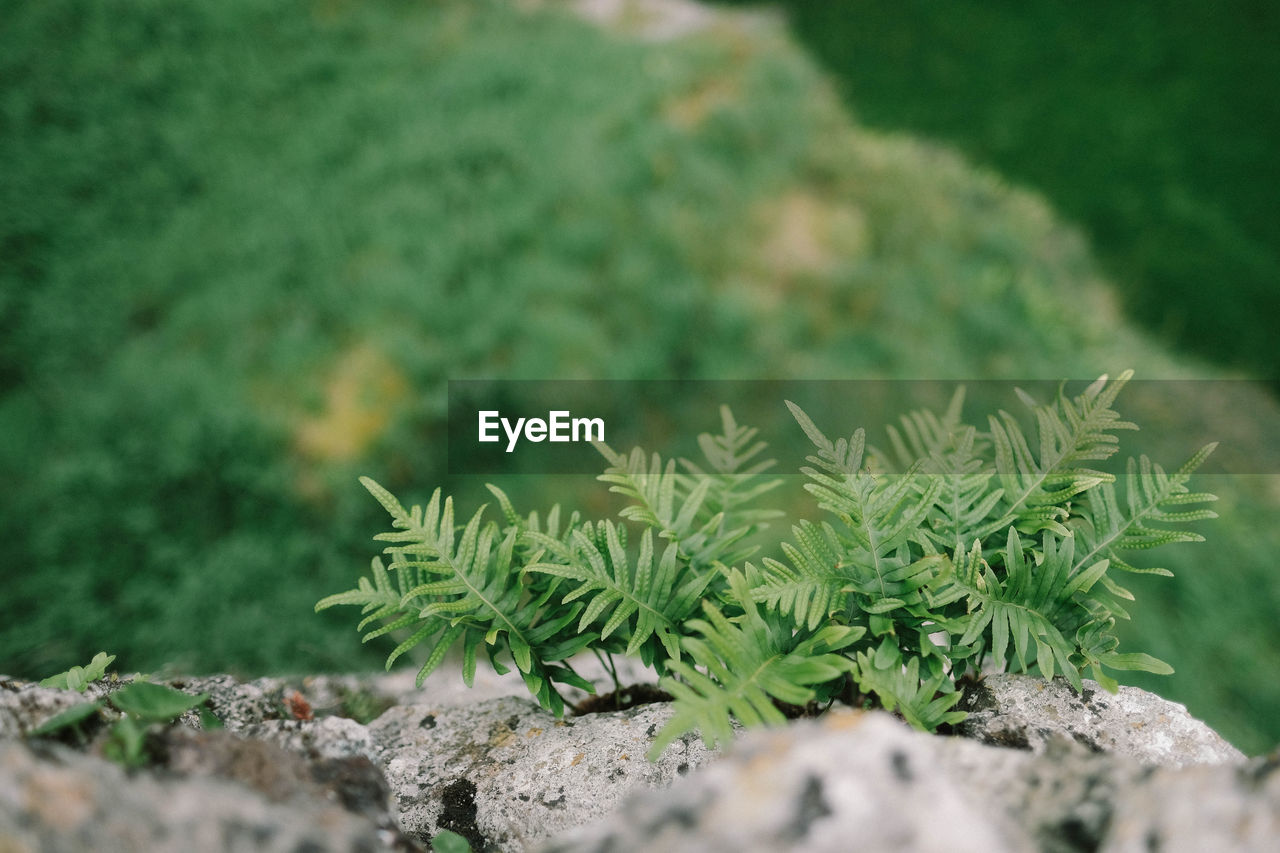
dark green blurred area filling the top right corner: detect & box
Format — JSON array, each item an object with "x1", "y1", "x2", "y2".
[{"x1": 721, "y1": 0, "x2": 1280, "y2": 387}]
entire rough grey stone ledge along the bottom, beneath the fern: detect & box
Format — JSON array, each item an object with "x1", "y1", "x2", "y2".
[{"x1": 0, "y1": 665, "x2": 1280, "y2": 853}]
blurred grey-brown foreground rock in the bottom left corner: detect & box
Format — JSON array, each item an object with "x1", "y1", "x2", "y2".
[{"x1": 0, "y1": 740, "x2": 411, "y2": 853}]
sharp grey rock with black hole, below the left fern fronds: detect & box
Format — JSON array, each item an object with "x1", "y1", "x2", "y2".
[{"x1": 370, "y1": 697, "x2": 712, "y2": 850}]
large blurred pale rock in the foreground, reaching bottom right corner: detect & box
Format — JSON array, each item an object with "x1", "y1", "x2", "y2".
[{"x1": 543, "y1": 711, "x2": 1280, "y2": 853}]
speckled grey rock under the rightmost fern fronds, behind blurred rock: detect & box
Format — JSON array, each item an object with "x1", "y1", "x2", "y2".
[{"x1": 959, "y1": 675, "x2": 1244, "y2": 767}]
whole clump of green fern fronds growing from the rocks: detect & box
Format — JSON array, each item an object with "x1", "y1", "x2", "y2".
[{"x1": 316, "y1": 373, "x2": 1216, "y2": 756}]
